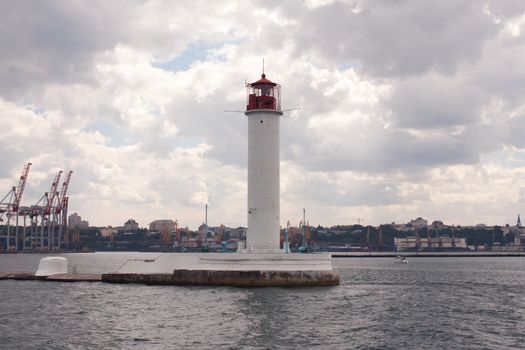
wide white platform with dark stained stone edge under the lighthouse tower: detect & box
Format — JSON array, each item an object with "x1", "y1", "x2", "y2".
[{"x1": 109, "y1": 253, "x2": 339, "y2": 287}]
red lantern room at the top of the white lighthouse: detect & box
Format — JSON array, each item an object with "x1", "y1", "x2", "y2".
[{"x1": 246, "y1": 73, "x2": 281, "y2": 111}]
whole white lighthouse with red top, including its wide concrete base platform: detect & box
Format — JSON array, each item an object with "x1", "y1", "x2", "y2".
[{"x1": 111, "y1": 70, "x2": 339, "y2": 286}]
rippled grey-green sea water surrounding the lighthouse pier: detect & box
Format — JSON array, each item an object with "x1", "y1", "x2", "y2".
[{"x1": 0, "y1": 253, "x2": 525, "y2": 350}]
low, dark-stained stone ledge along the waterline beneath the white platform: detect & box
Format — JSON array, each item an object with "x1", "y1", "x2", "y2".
[{"x1": 0, "y1": 270, "x2": 340, "y2": 287}]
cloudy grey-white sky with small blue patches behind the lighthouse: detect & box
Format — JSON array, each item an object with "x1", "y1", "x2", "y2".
[{"x1": 0, "y1": 0, "x2": 525, "y2": 228}]
